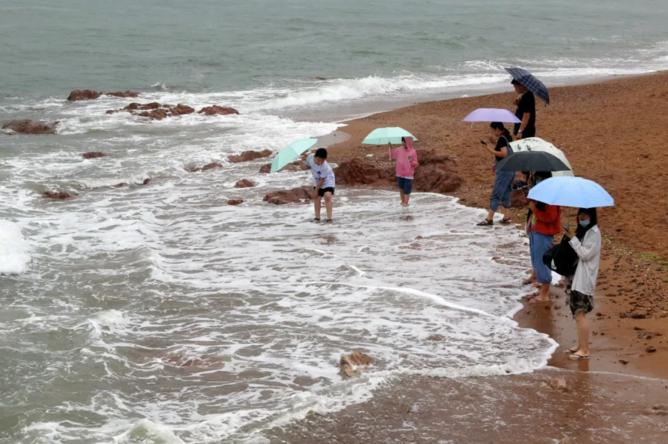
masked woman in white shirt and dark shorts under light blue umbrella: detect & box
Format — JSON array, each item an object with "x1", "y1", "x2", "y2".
[{"x1": 564, "y1": 208, "x2": 601, "y2": 360}]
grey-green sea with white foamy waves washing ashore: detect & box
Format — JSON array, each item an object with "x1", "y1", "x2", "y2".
[{"x1": 0, "y1": 0, "x2": 668, "y2": 443}]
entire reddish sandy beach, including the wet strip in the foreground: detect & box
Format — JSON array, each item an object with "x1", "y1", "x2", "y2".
[{"x1": 264, "y1": 72, "x2": 668, "y2": 442}]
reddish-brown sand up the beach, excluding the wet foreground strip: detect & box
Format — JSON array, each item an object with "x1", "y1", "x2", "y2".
[{"x1": 330, "y1": 73, "x2": 668, "y2": 378}]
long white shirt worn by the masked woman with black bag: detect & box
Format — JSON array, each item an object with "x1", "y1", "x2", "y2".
[{"x1": 569, "y1": 225, "x2": 601, "y2": 296}]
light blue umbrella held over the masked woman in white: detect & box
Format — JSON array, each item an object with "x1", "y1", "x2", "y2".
[{"x1": 529, "y1": 176, "x2": 615, "y2": 208}]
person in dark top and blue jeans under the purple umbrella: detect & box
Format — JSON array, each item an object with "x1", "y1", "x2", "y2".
[{"x1": 477, "y1": 122, "x2": 515, "y2": 226}]
